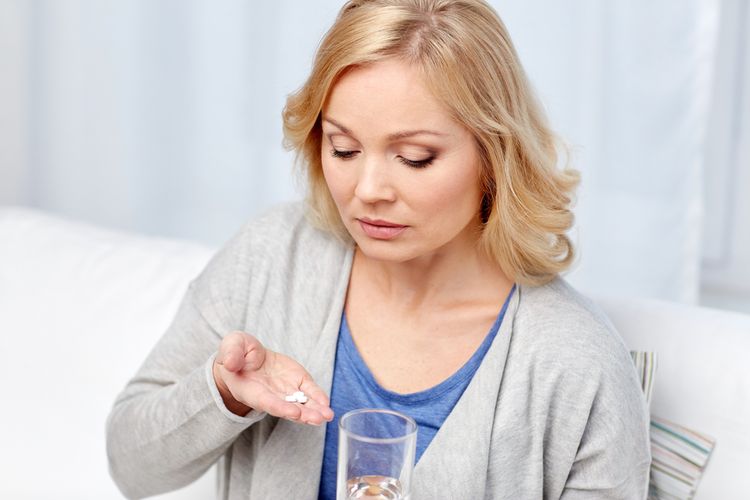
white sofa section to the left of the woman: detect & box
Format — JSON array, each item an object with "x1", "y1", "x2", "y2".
[{"x1": 0, "y1": 208, "x2": 213, "y2": 500}]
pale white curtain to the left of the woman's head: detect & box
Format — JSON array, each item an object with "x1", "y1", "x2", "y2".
[{"x1": 0, "y1": 0, "x2": 338, "y2": 243}]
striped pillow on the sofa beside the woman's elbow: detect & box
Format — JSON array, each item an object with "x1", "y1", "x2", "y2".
[{"x1": 630, "y1": 351, "x2": 716, "y2": 500}]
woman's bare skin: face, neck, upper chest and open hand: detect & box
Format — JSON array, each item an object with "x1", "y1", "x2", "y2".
[{"x1": 214, "y1": 55, "x2": 512, "y2": 424}]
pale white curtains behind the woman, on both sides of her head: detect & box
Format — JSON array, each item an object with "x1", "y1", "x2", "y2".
[{"x1": 0, "y1": 0, "x2": 718, "y2": 302}]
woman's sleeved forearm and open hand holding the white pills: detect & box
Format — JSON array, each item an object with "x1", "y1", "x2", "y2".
[{"x1": 107, "y1": 289, "x2": 333, "y2": 497}]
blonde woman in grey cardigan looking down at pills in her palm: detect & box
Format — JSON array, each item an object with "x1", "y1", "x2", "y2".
[{"x1": 108, "y1": 0, "x2": 650, "y2": 499}]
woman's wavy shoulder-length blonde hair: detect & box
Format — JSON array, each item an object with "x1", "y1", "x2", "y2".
[{"x1": 283, "y1": 0, "x2": 579, "y2": 285}]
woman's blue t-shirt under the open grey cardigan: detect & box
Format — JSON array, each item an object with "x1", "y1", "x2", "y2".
[{"x1": 318, "y1": 286, "x2": 515, "y2": 500}]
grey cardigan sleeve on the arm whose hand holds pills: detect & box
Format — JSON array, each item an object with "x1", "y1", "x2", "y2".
[{"x1": 107, "y1": 220, "x2": 265, "y2": 498}]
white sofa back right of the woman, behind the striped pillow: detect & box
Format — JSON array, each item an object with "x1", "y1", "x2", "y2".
[{"x1": 597, "y1": 297, "x2": 750, "y2": 500}]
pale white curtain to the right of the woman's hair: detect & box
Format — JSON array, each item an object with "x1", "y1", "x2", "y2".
[{"x1": 497, "y1": 0, "x2": 719, "y2": 302}]
